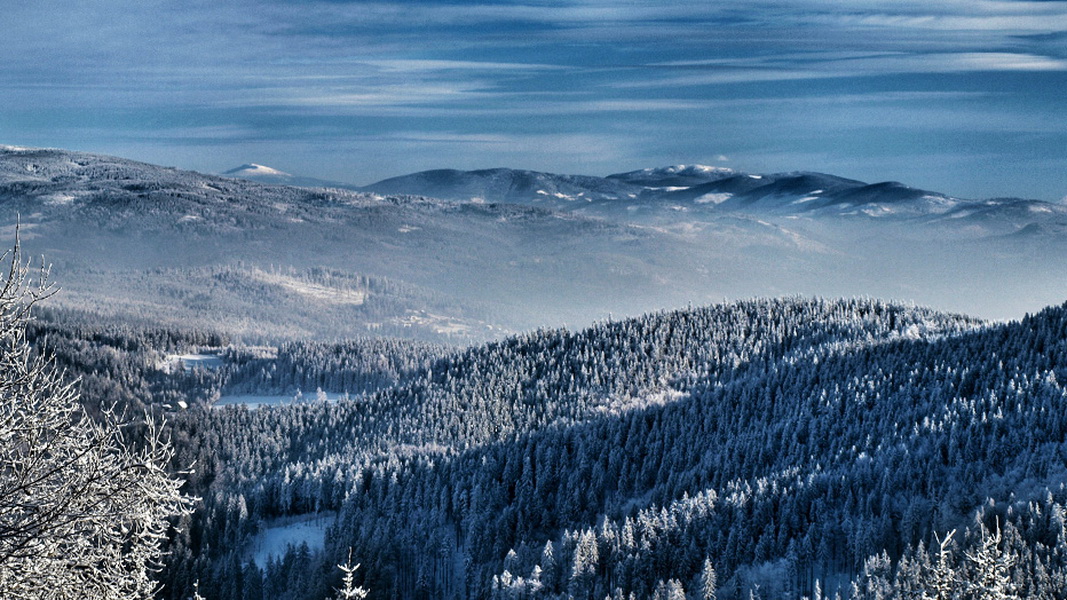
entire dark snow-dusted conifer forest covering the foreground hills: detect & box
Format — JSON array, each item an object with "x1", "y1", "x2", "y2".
[{"x1": 29, "y1": 299, "x2": 1067, "y2": 600}]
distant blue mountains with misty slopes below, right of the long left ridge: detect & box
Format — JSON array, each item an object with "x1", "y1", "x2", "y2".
[{"x1": 218, "y1": 154, "x2": 1067, "y2": 318}]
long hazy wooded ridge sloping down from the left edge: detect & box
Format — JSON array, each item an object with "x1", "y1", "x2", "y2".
[{"x1": 0, "y1": 147, "x2": 734, "y2": 343}]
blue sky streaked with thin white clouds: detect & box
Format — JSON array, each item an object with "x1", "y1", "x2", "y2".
[{"x1": 0, "y1": 0, "x2": 1067, "y2": 202}]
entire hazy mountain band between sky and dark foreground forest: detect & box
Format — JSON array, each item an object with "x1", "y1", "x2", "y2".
[{"x1": 0, "y1": 146, "x2": 1067, "y2": 343}]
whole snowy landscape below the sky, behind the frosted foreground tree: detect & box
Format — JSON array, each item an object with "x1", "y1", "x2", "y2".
[{"x1": 6, "y1": 148, "x2": 1067, "y2": 600}]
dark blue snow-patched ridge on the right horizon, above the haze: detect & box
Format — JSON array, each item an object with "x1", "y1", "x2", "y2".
[{"x1": 361, "y1": 164, "x2": 1067, "y2": 227}]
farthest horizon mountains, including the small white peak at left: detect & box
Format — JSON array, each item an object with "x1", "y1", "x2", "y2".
[{"x1": 233, "y1": 159, "x2": 1067, "y2": 247}]
